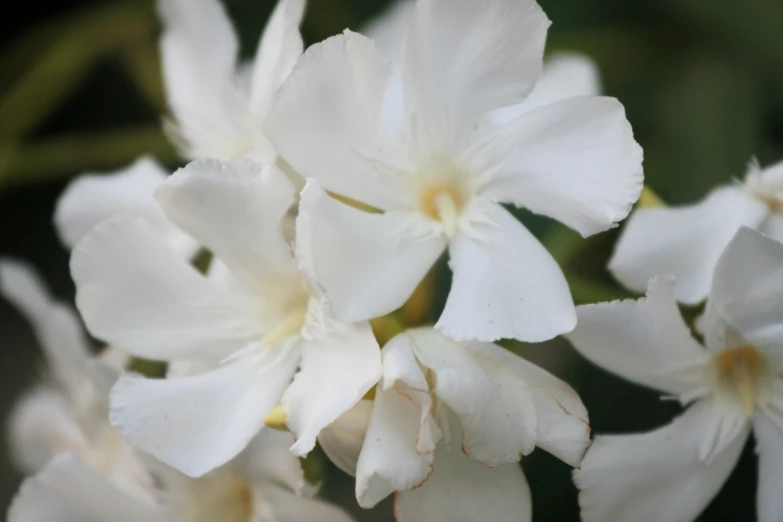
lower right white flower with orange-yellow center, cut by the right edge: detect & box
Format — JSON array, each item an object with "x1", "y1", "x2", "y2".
[{"x1": 569, "y1": 227, "x2": 783, "y2": 522}]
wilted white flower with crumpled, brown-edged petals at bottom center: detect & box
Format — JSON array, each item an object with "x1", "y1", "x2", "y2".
[{"x1": 320, "y1": 328, "x2": 590, "y2": 522}]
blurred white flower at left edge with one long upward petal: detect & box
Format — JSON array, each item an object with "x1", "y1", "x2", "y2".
[{"x1": 0, "y1": 260, "x2": 148, "y2": 498}]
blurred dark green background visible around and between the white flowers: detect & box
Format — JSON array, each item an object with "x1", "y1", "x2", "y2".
[{"x1": 0, "y1": 0, "x2": 783, "y2": 522}]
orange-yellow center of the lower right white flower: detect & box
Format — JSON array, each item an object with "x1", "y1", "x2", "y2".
[{"x1": 715, "y1": 345, "x2": 771, "y2": 415}]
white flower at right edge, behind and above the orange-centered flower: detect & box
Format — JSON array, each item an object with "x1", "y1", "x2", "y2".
[{"x1": 609, "y1": 158, "x2": 783, "y2": 304}]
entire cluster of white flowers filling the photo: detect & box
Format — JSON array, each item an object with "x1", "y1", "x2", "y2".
[{"x1": 0, "y1": 0, "x2": 783, "y2": 522}]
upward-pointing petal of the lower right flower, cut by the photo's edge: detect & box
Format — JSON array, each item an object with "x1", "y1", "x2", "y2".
[{"x1": 704, "y1": 227, "x2": 783, "y2": 350}]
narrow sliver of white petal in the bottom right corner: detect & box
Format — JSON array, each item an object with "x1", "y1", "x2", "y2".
[{"x1": 753, "y1": 406, "x2": 783, "y2": 522}]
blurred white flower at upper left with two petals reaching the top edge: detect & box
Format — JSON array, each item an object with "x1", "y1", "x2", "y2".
[{"x1": 158, "y1": 0, "x2": 305, "y2": 162}]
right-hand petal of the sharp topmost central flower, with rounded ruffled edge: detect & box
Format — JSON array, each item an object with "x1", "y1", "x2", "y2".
[{"x1": 484, "y1": 96, "x2": 643, "y2": 237}]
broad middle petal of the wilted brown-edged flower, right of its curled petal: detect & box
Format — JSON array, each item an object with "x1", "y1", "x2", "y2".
[{"x1": 407, "y1": 328, "x2": 536, "y2": 467}]
